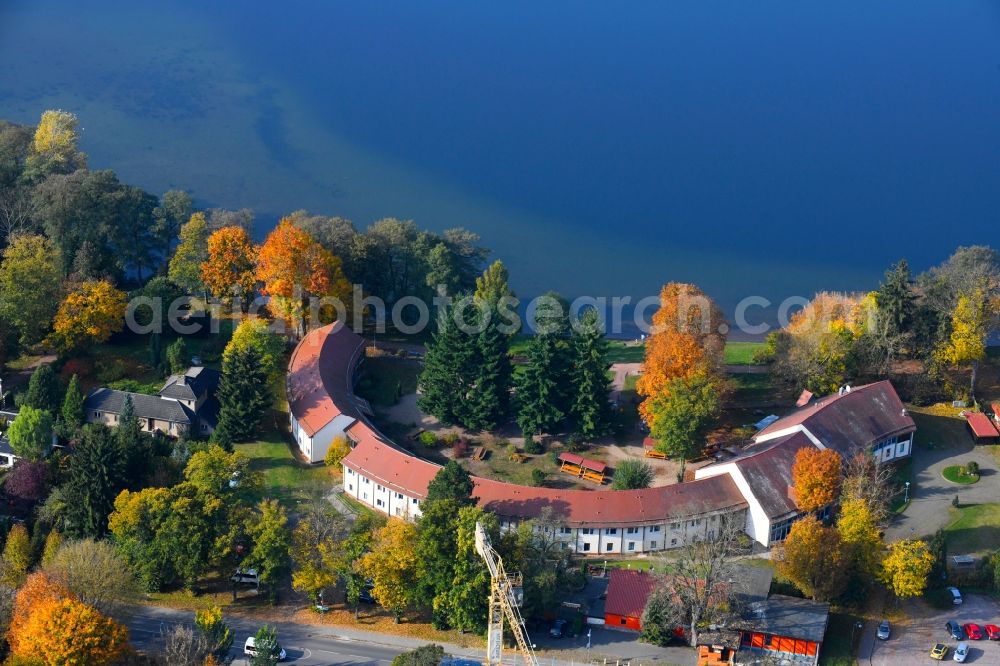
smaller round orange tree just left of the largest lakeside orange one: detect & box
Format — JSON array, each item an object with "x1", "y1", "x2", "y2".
[{"x1": 201, "y1": 226, "x2": 257, "y2": 312}]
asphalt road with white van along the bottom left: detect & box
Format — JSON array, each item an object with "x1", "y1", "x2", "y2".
[{"x1": 120, "y1": 608, "x2": 403, "y2": 666}]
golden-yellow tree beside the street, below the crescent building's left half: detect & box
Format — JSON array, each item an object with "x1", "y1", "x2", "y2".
[{"x1": 358, "y1": 518, "x2": 419, "y2": 623}]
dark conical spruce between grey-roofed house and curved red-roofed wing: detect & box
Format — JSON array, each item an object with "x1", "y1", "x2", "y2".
[{"x1": 218, "y1": 347, "x2": 271, "y2": 441}]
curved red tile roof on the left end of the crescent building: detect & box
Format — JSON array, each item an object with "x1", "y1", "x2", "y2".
[{"x1": 286, "y1": 323, "x2": 365, "y2": 437}]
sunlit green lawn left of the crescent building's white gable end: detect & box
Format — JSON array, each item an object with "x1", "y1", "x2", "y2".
[{"x1": 236, "y1": 429, "x2": 332, "y2": 506}]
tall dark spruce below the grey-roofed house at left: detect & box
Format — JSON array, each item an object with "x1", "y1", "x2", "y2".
[{"x1": 62, "y1": 425, "x2": 125, "y2": 539}]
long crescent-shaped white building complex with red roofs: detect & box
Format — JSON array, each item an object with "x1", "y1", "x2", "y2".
[{"x1": 287, "y1": 324, "x2": 914, "y2": 555}]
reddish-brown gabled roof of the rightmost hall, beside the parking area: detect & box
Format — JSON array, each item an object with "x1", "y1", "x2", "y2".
[{"x1": 755, "y1": 380, "x2": 916, "y2": 455}]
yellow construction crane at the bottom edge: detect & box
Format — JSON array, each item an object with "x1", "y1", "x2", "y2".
[{"x1": 476, "y1": 523, "x2": 538, "y2": 666}]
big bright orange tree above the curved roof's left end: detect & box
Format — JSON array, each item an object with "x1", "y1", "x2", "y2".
[{"x1": 257, "y1": 218, "x2": 351, "y2": 335}]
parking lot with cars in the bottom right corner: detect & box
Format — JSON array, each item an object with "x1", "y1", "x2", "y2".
[{"x1": 871, "y1": 594, "x2": 1000, "y2": 666}]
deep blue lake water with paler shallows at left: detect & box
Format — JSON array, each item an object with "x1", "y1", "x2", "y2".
[{"x1": 0, "y1": 0, "x2": 1000, "y2": 322}]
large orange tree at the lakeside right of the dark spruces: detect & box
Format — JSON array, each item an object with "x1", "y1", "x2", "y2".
[{"x1": 636, "y1": 282, "x2": 726, "y2": 455}]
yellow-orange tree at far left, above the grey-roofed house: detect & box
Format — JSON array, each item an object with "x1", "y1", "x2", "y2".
[{"x1": 51, "y1": 280, "x2": 127, "y2": 352}]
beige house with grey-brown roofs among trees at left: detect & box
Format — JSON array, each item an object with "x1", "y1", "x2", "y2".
[{"x1": 84, "y1": 367, "x2": 220, "y2": 437}]
